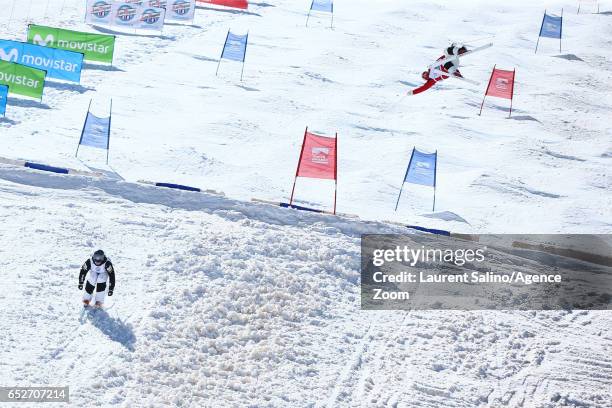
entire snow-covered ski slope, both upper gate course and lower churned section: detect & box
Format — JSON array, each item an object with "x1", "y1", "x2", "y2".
[{"x1": 0, "y1": 0, "x2": 612, "y2": 408}]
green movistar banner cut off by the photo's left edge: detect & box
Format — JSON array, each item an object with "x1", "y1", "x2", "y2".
[{"x1": 0, "y1": 61, "x2": 47, "y2": 99}]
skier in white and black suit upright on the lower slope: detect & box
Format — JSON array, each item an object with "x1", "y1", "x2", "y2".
[{"x1": 79, "y1": 249, "x2": 115, "y2": 307}]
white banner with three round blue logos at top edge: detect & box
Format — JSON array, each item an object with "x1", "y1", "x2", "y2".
[{"x1": 85, "y1": 0, "x2": 166, "y2": 31}]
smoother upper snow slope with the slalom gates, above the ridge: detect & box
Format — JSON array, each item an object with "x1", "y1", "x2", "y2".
[{"x1": 0, "y1": 0, "x2": 612, "y2": 233}]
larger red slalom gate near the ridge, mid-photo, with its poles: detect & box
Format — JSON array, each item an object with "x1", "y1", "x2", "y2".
[{"x1": 289, "y1": 127, "x2": 338, "y2": 214}]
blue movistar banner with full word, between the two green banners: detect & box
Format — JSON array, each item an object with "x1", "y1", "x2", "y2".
[{"x1": 0, "y1": 40, "x2": 83, "y2": 83}]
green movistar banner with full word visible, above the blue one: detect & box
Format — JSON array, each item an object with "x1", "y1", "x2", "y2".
[{"x1": 28, "y1": 24, "x2": 115, "y2": 63}]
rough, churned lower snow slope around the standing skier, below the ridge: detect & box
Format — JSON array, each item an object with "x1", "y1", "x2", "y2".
[{"x1": 0, "y1": 167, "x2": 612, "y2": 407}]
